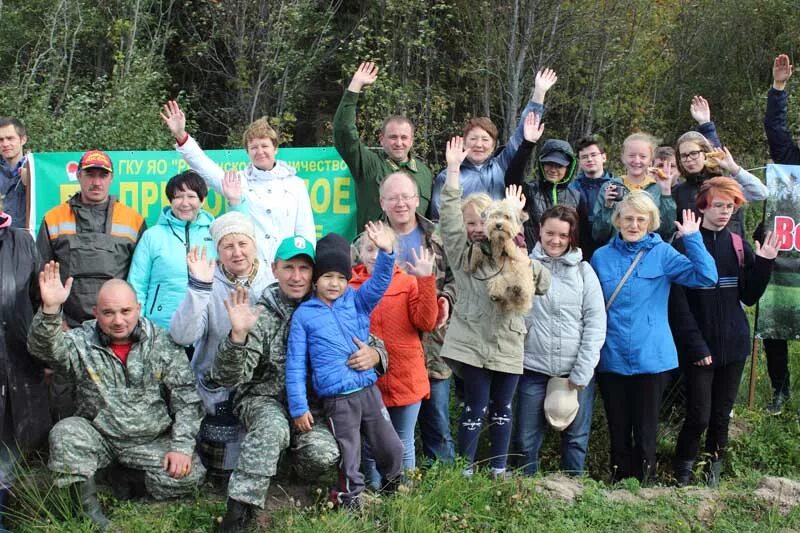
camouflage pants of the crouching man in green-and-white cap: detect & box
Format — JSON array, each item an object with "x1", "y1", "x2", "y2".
[{"x1": 228, "y1": 396, "x2": 339, "y2": 508}]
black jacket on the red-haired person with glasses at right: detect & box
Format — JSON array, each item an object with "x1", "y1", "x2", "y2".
[{"x1": 669, "y1": 228, "x2": 774, "y2": 366}]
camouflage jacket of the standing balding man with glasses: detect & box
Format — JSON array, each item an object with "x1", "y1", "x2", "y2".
[{"x1": 417, "y1": 215, "x2": 456, "y2": 379}]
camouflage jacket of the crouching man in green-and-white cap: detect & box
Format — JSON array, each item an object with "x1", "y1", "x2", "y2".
[{"x1": 211, "y1": 282, "x2": 387, "y2": 404}]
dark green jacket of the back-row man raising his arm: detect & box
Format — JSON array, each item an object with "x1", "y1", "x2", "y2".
[{"x1": 333, "y1": 91, "x2": 433, "y2": 231}]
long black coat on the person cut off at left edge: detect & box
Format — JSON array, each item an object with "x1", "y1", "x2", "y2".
[{"x1": 0, "y1": 220, "x2": 50, "y2": 450}]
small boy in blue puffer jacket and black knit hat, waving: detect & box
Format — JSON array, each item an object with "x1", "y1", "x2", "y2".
[{"x1": 286, "y1": 222, "x2": 403, "y2": 509}]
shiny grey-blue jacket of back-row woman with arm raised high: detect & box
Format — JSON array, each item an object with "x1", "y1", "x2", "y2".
[{"x1": 429, "y1": 101, "x2": 544, "y2": 220}]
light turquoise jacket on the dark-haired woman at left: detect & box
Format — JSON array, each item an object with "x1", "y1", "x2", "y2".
[{"x1": 128, "y1": 206, "x2": 217, "y2": 330}]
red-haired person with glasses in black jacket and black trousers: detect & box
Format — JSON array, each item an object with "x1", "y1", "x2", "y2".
[{"x1": 669, "y1": 179, "x2": 778, "y2": 487}]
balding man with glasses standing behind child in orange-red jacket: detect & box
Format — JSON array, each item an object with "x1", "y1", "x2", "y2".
[{"x1": 380, "y1": 172, "x2": 455, "y2": 463}]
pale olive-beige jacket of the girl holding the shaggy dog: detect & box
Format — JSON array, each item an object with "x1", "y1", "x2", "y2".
[{"x1": 439, "y1": 185, "x2": 550, "y2": 374}]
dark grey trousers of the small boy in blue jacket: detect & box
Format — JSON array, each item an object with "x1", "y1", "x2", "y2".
[{"x1": 323, "y1": 384, "x2": 403, "y2": 504}]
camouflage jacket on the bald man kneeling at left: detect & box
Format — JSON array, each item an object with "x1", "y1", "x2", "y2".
[{"x1": 28, "y1": 310, "x2": 203, "y2": 455}]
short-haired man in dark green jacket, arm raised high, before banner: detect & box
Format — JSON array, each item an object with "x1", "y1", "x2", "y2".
[{"x1": 333, "y1": 62, "x2": 433, "y2": 231}]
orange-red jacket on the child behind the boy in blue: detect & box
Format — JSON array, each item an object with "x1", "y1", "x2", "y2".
[{"x1": 350, "y1": 265, "x2": 438, "y2": 407}]
